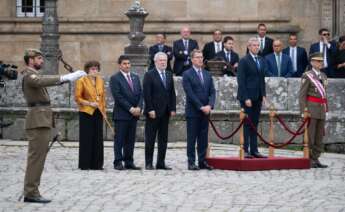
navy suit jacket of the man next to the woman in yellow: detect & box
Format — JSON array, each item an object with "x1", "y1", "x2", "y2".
[{"x1": 110, "y1": 71, "x2": 143, "y2": 121}]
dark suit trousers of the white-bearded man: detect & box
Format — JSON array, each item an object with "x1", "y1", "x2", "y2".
[{"x1": 145, "y1": 114, "x2": 170, "y2": 166}]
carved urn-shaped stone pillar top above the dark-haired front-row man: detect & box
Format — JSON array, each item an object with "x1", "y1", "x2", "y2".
[{"x1": 125, "y1": 1, "x2": 149, "y2": 79}]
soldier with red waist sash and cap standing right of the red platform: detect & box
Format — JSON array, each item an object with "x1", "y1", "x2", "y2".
[{"x1": 299, "y1": 52, "x2": 328, "y2": 168}]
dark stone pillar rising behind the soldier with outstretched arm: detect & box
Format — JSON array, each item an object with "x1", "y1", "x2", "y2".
[{"x1": 41, "y1": 0, "x2": 60, "y2": 74}]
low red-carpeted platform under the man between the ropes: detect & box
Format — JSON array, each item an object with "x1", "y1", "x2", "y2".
[{"x1": 206, "y1": 156, "x2": 310, "y2": 171}]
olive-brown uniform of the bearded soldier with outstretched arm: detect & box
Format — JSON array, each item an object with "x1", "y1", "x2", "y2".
[{"x1": 22, "y1": 67, "x2": 61, "y2": 198}]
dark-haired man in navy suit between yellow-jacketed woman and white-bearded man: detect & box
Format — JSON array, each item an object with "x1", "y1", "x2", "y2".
[{"x1": 110, "y1": 55, "x2": 143, "y2": 170}]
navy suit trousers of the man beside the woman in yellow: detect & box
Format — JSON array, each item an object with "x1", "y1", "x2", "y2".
[{"x1": 114, "y1": 120, "x2": 137, "y2": 165}]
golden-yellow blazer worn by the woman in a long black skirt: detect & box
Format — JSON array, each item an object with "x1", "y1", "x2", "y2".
[{"x1": 74, "y1": 76, "x2": 106, "y2": 118}]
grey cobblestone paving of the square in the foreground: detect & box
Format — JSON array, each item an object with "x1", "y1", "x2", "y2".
[{"x1": 0, "y1": 140, "x2": 345, "y2": 212}]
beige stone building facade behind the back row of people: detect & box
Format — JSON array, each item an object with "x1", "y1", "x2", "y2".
[{"x1": 0, "y1": 0, "x2": 338, "y2": 75}]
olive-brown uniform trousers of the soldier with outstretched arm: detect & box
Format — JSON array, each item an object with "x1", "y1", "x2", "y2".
[{"x1": 24, "y1": 127, "x2": 51, "y2": 198}]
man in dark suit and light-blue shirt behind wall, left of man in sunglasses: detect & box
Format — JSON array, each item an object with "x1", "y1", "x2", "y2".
[{"x1": 283, "y1": 33, "x2": 308, "y2": 77}]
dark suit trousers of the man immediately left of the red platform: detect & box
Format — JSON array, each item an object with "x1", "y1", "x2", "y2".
[{"x1": 186, "y1": 116, "x2": 208, "y2": 164}]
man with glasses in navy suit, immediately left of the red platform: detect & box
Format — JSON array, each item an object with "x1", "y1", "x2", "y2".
[{"x1": 182, "y1": 50, "x2": 216, "y2": 170}]
